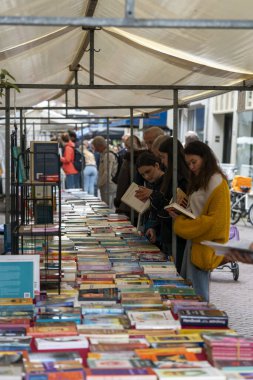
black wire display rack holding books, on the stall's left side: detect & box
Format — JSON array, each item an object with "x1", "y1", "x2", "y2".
[{"x1": 11, "y1": 140, "x2": 62, "y2": 294}]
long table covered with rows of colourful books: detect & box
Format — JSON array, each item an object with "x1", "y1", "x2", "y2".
[{"x1": 0, "y1": 190, "x2": 253, "y2": 380}]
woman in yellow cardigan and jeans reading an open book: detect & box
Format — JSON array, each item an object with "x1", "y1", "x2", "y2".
[{"x1": 167, "y1": 141, "x2": 230, "y2": 301}]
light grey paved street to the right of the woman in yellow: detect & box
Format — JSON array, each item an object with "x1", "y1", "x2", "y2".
[{"x1": 210, "y1": 221, "x2": 253, "y2": 336}]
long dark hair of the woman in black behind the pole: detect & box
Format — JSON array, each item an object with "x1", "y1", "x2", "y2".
[{"x1": 159, "y1": 137, "x2": 189, "y2": 194}]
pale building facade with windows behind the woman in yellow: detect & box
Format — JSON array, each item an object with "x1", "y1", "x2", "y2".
[{"x1": 168, "y1": 91, "x2": 253, "y2": 177}]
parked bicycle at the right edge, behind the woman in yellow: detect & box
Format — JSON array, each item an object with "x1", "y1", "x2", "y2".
[{"x1": 231, "y1": 186, "x2": 253, "y2": 225}]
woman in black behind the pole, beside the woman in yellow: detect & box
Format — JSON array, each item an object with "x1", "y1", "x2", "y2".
[{"x1": 136, "y1": 137, "x2": 189, "y2": 271}]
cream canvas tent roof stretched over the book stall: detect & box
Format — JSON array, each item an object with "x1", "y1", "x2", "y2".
[{"x1": 0, "y1": 0, "x2": 253, "y2": 116}]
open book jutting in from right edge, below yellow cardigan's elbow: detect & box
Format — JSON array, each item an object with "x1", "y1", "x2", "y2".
[{"x1": 201, "y1": 240, "x2": 253, "y2": 258}]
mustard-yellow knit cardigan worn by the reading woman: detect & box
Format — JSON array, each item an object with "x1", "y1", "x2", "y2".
[{"x1": 174, "y1": 179, "x2": 230, "y2": 271}]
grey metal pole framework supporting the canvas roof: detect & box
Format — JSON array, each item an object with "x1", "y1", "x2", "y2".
[{"x1": 0, "y1": 0, "x2": 253, "y2": 252}]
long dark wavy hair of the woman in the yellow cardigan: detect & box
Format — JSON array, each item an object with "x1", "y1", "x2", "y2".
[{"x1": 184, "y1": 141, "x2": 226, "y2": 194}]
